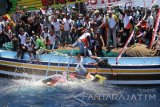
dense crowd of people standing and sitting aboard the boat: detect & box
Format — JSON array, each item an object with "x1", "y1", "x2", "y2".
[{"x1": 0, "y1": 5, "x2": 160, "y2": 59}]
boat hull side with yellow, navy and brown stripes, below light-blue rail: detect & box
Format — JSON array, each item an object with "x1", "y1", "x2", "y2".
[{"x1": 0, "y1": 58, "x2": 160, "y2": 84}]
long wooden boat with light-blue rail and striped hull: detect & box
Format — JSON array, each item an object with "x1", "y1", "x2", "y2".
[{"x1": 0, "y1": 50, "x2": 160, "y2": 84}]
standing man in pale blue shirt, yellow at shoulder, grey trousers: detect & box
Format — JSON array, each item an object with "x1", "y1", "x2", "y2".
[{"x1": 106, "y1": 11, "x2": 118, "y2": 47}]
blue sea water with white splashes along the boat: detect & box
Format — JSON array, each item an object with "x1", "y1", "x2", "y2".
[{"x1": 0, "y1": 78, "x2": 160, "y2": 107}]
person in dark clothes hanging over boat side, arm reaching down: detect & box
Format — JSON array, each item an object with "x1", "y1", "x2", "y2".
[{"x1": 91, "y1": 56, "x2": 117, "y2": 76}]
